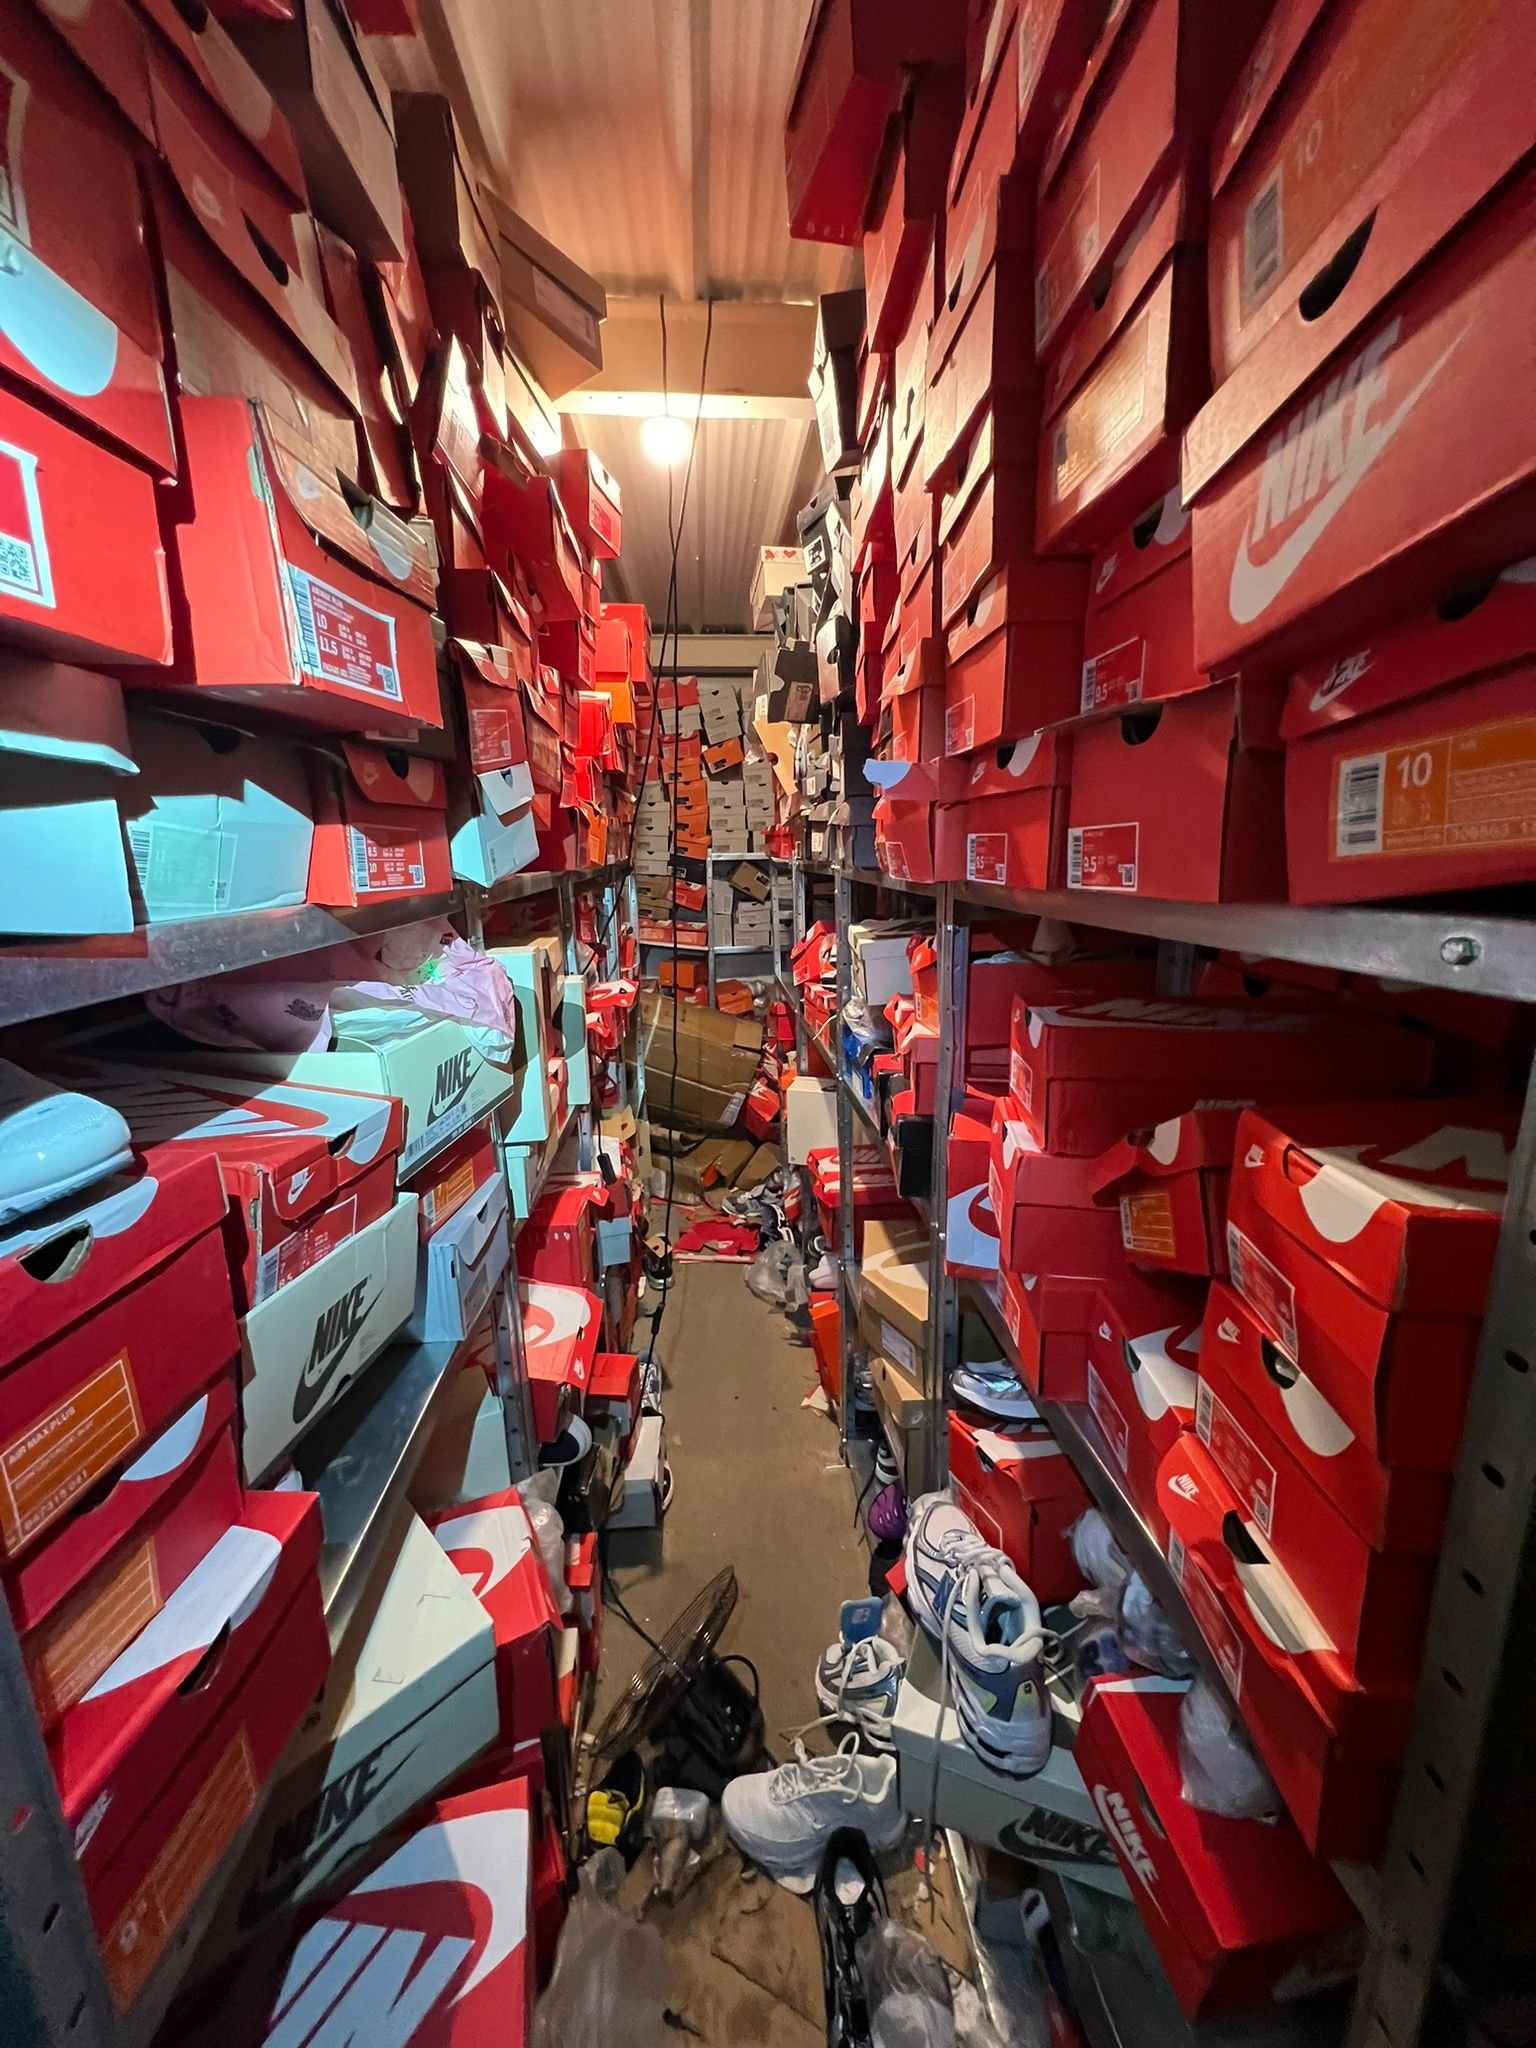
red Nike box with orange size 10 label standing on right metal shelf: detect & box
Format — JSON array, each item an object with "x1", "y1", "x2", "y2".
[{"x1": 1280, "y1": 561, "x2": 1536, "y2": 903}]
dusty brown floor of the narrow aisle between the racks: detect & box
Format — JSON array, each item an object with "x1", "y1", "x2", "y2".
[{"x1": 592, "y1": 1264, "x2": 967, "y2": 2048}]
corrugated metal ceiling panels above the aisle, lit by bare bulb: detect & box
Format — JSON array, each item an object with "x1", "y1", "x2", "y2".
[{"x1": 423, "y1": 0, "x2": 856, "y2": 629}]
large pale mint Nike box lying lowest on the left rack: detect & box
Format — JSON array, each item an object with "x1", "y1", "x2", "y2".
[{"x1": 231, "y1": 1511, "x2": 500, "y2": 1929}]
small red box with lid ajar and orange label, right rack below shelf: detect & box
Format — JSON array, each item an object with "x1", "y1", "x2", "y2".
[{"x1": 1094, "y1": 1110, "x2": 1241, "y2": 1278}]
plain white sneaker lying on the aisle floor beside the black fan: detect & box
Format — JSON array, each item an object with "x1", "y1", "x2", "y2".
[{"x1": 721, "y1": 1735, "x2": 907, "y2": 1884}]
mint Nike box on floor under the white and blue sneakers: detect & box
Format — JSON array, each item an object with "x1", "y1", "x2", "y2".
[{"x1": 891, "y1": 1630, "x2": 1130, "y2": 1898}]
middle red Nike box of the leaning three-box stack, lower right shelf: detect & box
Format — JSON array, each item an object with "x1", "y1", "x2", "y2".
[{"x1": 1196, "y1": 1284, "x2": 1446, "y2": 1686}]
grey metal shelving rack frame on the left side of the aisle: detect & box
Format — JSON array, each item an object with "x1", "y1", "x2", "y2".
[{"x1": 0, "y1": 866, "x2": 635, "y2": 2048}]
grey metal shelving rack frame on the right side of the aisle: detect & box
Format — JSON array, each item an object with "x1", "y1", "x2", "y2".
[{"x1": 794, "y1": 862, "x2": 1536, "y2": 2048}]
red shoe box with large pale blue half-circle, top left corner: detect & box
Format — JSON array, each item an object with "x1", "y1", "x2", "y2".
[{"x1": 0, "y1": 8, "x2": 176, "y2": 475}]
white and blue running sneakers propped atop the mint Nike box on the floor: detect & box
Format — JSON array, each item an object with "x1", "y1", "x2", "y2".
[{"x1": 907, "y1": 1493, "x2": 1051, "y2": 1778}]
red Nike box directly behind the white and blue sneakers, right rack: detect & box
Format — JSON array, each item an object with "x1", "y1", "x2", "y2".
[{"x1": 948, "y1": 1397, "x2": 1094, "y2": 1606}]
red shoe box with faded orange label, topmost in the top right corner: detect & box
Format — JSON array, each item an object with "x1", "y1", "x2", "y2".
[{"x1": 1210, "y1": 0, "x2": 1532, "y2": 456}]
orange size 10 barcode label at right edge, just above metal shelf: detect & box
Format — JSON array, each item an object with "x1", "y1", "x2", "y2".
[{"x1": 1333, "y1": 717, "x2": 1536, "y2": 860}]
